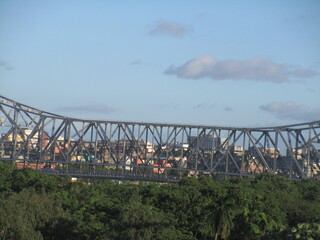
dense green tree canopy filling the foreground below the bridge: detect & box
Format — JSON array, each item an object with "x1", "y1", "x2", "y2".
[{"x1": 0, "y1": 164, "x2": 320, "y2": 240}]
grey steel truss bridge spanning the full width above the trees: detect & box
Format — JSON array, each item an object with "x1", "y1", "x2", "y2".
[{"x1": 0, "y1": 96, "x2": 320, "y2": 182}]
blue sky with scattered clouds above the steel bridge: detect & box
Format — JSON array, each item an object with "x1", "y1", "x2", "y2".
[{"x1": 0, "y1": 0, "x2": 320, "y2": 126}]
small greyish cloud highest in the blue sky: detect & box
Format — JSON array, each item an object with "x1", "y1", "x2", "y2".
[{"x1": 149, "y1": 20, "x2": 192, "y2": 37}]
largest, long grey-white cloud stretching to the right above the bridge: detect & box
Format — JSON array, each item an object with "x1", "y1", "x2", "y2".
[{"x1": 164, "y1": 56, "x2": 316, "y2": 83}]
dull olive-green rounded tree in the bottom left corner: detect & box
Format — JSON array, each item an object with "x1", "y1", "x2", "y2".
[{"x1": 0, "y1": 188, "x2": 64, "y2": 240}]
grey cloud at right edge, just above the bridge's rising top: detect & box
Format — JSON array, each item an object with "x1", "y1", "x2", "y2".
[{"x1": 260, "y1": 101, "x2": 320, "y2": 121}]
